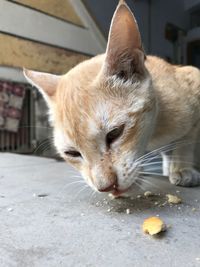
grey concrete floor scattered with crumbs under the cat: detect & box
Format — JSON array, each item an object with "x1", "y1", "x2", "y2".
[{"x1": 0, "y1": 154, "x2": 200, "y2": 267}]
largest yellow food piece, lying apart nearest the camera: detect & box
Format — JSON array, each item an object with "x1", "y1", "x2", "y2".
[{"x1": 142, "y1": 217, "x2": 166, "y2": 235}]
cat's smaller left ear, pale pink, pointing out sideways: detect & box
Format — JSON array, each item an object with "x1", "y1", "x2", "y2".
[{"x1": 23, "y1": 69, "x2": 60, "y2": 105}]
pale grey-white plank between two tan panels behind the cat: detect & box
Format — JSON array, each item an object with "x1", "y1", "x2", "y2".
[{"x1": 0, "y1": 0, "x2": 103, "y2": 55}]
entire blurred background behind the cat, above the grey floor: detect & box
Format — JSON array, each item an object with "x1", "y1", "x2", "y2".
[{"x1": 0, "y1": 0, "x2": 200, "y2": 157}]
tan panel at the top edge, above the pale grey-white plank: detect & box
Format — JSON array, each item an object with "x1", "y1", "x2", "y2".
[{"x1": 12, "y1": 0, "x2": 84, "y2": 27}]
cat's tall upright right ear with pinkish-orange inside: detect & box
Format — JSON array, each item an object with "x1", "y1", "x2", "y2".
[{"x1": 104, "y1": 0, "x2": 145, "y2": 80}]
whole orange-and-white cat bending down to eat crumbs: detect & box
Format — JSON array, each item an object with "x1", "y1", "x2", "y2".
[{"x1": 24, "y1": 1, "x2": 200, "y2": 196}]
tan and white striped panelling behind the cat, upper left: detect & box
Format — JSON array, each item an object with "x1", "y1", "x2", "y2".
[{"x1": 0, "y1": 0, "x2": 92, "y2": 79}]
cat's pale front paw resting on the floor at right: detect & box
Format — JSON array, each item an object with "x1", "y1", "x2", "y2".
[{"x1": 169, "y1": 168, "x2": 200, "y2": 187}]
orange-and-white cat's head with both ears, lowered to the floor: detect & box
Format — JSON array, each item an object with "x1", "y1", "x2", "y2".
[{"x1": 24, "y1": 1, "x2": 156, "y2": 195}]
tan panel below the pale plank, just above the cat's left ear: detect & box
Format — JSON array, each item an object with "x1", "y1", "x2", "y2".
[{"x1": 0, "y1": 33, "x2": 89, "y2": 74}]
